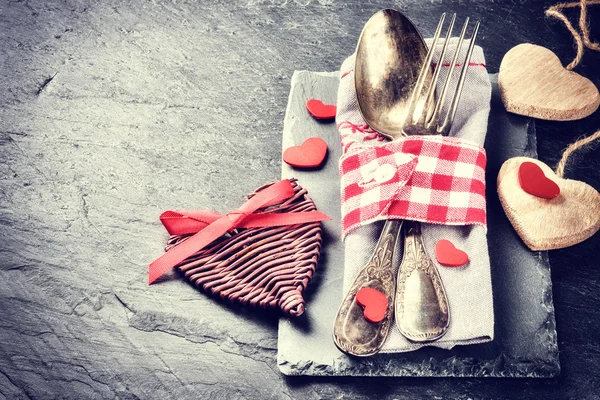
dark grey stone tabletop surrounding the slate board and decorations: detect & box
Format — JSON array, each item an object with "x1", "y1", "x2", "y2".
[{"x1": 0, "y1": 0, "x2": 600, "y2": 399}]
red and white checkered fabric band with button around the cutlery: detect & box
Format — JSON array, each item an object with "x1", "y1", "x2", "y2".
[{"x1": 338, "y1": 134, "x2": 486, "y2": 237}]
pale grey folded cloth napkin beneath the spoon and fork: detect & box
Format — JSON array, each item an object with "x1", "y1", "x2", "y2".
[{"x1": 336, "y1": 38, "x2": 494, "y2": 353}]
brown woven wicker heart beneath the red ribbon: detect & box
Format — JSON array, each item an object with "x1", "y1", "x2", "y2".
[{"x1": 166, "y1": 180, "x2": 321, "y2": 317}]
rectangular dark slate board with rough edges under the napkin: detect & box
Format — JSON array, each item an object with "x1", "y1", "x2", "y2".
[{"x1": 277, "y1": 71, "x2": 560, "y2": 378}]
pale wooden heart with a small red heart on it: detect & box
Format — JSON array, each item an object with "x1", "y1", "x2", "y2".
[{"x1": 497, "y1": 157, "x2": 600, "y2": 250}]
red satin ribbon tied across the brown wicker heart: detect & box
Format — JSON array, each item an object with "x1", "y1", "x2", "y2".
[{"x1": 148, "y1": 179, "x2": 331, "y2": 284}]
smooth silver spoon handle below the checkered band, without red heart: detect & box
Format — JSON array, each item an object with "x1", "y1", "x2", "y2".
[{"x1": 395, "y1": 221, "x2": 449, "y2": 342}]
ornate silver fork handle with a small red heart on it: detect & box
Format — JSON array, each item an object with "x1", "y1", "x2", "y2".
[{"x1": 333, "y1": 220, "x2": 402, "y2": 357}]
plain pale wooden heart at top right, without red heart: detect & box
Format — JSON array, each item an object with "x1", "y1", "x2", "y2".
[{"x1": 498, "y1": 43, "x2": 600, "y2": 121}]
